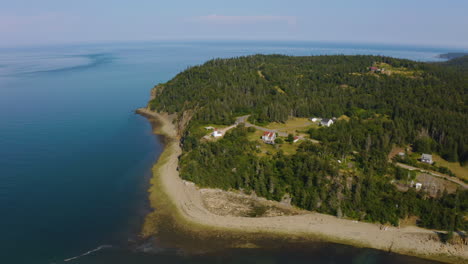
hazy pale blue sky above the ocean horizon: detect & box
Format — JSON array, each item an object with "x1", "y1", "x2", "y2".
[{"x1": 0, "y1": 0, "x2": 468, "y2": 48}]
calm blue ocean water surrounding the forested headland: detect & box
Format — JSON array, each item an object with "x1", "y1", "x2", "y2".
[{"x1": 0, "y1": 41, "x2": 457, "y2": 264}]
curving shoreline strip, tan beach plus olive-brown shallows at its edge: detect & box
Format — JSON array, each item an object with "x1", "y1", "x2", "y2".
[{"x1": 137, "y1": 109, "x2": 468, "y2": 263}]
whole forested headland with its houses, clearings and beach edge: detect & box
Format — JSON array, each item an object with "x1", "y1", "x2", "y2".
[{"x1": 138, "y1": 55, "x2": 468, "y2": 262}]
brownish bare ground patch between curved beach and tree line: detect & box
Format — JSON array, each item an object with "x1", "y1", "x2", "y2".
[{"x1": 200, "y1": 189, "x2": 304, "y2": 217}]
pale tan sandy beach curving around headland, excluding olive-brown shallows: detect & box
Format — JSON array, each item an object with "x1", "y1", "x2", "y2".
[{"x1": 137, "y1": 109, "x2": 468, "y2": 263}]
